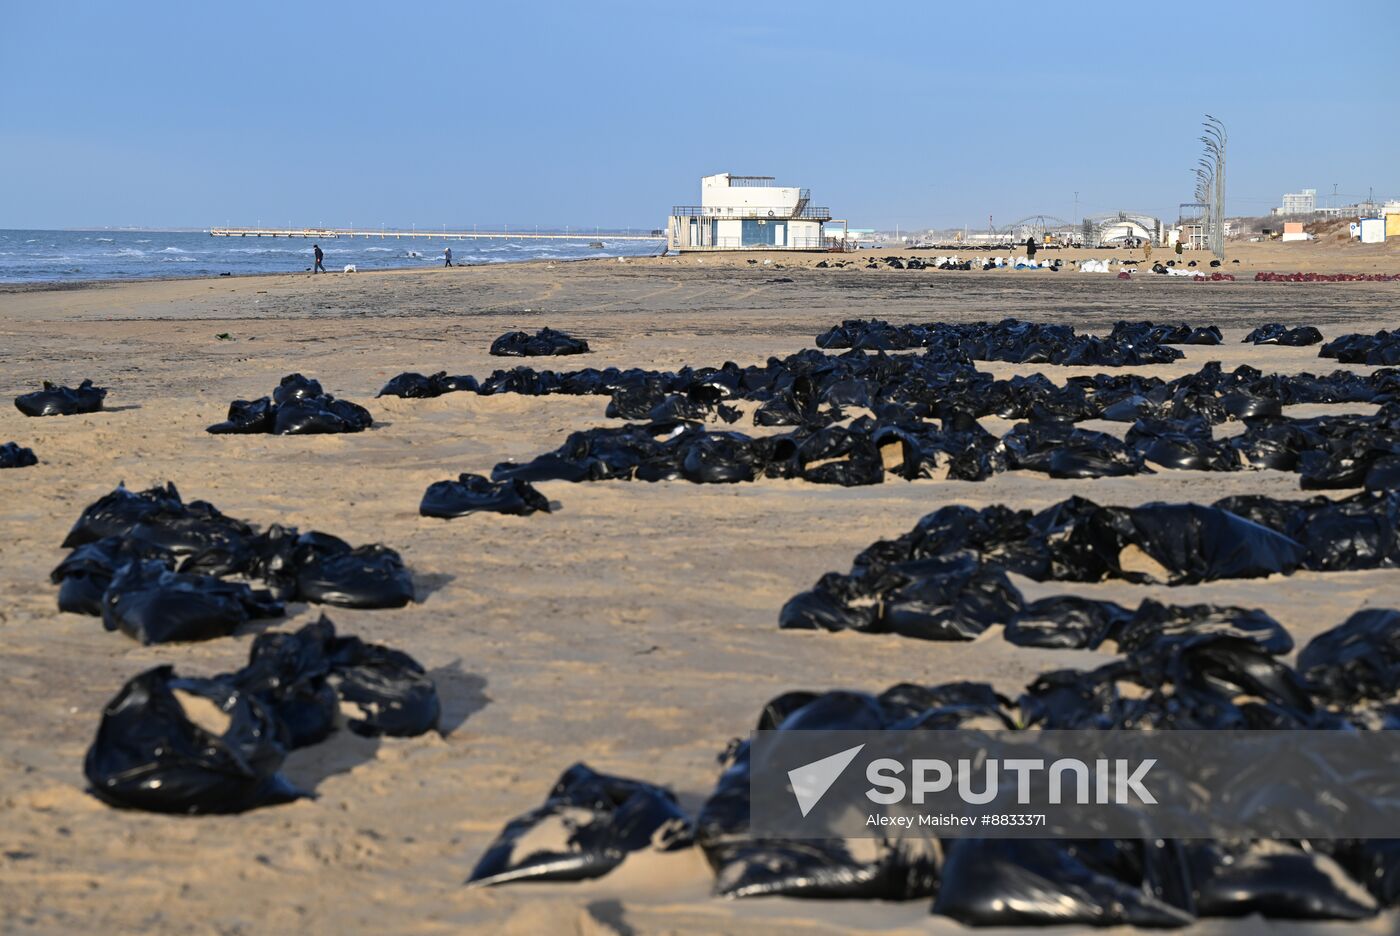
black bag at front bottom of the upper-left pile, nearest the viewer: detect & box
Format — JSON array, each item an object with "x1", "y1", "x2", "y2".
[{"x1": 102, "y1": 560, "x2": 283, "y2": 644}]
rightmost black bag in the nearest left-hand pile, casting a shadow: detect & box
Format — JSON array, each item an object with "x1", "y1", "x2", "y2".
[{"x1": 322, "y1": 632, "x2": 442, "y2": 737}]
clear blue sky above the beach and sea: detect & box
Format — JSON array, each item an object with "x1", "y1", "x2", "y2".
[{"x1": 0, "y1": 0, "x2": 1400, "y2": 228}]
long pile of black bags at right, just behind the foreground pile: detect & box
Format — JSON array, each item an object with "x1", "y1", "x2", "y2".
[{"x1": 778, "y1": 492, "x2": 1400, "y2": 637}]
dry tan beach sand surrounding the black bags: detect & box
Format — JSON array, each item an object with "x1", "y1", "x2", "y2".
[{"x1": 0, "y1": 245, "x2": 1400, "y2": 933}]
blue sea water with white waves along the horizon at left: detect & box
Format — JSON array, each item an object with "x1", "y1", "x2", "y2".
[{"x1": 0, "y1": 231, "x2": 662, "y2": 283}]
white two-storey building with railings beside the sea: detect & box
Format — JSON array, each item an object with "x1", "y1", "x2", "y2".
[{"x1": 666, "y1": 172, "x2": 832, "y2": 250}]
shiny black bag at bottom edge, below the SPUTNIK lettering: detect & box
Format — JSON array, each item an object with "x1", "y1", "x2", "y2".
[{"x1": 932, "y1": 838, "x2": 1194, "y2": 928}]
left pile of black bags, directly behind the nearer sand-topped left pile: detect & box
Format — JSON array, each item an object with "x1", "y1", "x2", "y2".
[{"x1": 50, "y1": 484, "x2": 413, "y2": 644}]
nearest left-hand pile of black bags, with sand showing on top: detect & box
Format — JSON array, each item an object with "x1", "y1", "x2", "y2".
[{"x1": 84, "y1": 617, "x2": 440, "y2": 813}]
